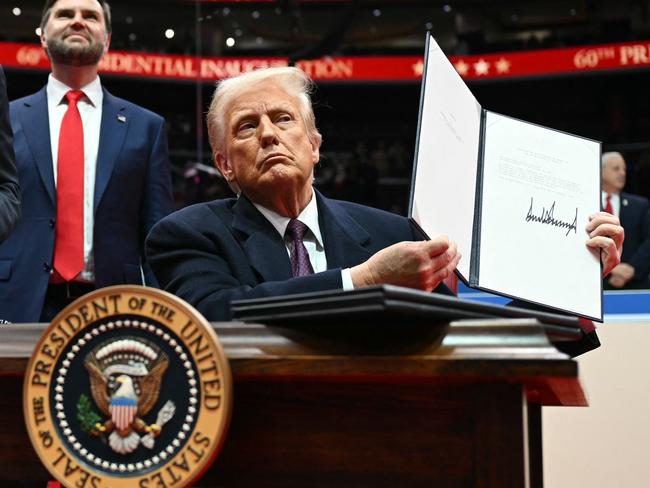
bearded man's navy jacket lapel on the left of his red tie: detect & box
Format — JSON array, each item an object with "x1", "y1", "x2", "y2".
[{"x1": 19, "y1": 87, "x2": 56, "y2": 205}]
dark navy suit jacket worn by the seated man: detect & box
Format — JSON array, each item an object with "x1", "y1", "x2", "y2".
[{"x1": 147, "y1": 192, "x2": 450, "y2": 320}]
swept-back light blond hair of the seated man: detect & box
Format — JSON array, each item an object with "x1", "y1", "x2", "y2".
[{"x1": 206, "y1": 66, "x2": 323, "y2": 158}]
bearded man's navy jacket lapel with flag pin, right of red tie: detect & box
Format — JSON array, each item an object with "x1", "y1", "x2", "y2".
[{"x1": 94, "y1": 89, "x2": 129, "y2": 212}]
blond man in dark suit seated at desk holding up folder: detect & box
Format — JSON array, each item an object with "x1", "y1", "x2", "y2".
[{"x1": 147, "y1": 68, "x2": 618, "y2": 320}]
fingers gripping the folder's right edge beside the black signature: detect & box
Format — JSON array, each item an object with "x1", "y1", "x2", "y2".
[{"x1": 587, "y1": 212, "x2": 625, "y2": 276}]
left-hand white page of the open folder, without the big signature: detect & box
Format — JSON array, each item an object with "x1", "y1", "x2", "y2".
[{"x1": 409, "y1": 38, "x2": 481, "y2": 280}]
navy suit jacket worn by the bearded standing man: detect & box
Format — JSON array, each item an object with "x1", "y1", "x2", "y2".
[{"x1": 0, "y1": 88, "x2": 173, "y2": 322}]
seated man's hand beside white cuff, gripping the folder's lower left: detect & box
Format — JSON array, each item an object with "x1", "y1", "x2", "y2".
[{"x1": 350, "y1": 236, "x2": 461, "y2": 291}]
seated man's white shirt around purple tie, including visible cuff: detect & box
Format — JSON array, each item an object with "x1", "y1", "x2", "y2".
[{"x1": 253, "y1": 192, "x2": 354, "y2": 290}]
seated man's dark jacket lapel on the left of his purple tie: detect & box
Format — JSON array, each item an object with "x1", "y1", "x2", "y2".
[{"x1": 232, "y1": 196, "x2": 292, "y2": 281}]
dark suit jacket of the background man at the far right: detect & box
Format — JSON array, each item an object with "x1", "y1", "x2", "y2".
[{"x1": 619, "y1": 193, "x2": 650, "y2": 287}]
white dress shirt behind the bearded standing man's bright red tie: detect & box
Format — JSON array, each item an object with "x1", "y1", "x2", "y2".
[{"x1": 46, "y1": 74, "x2": 104, "y2": 283}]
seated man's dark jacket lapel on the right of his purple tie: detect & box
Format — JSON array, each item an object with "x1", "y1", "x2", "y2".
[{"x1": 314, "y1": 190, "x2": 372, "y2": 269}]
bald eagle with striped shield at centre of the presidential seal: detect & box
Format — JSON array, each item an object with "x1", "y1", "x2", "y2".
[{"x1": 84, "y1": 337, "x2": 175, "y2": 454}]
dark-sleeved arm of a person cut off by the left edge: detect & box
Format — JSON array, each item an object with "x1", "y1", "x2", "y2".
[{"x1": 0, "y1": 67, "x2": 20, "y2": 244}]
